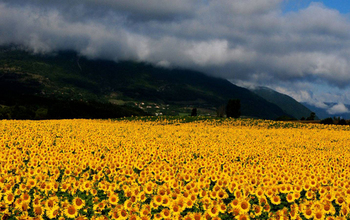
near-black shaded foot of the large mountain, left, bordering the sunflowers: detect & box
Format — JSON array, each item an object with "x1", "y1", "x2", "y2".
[{"x1": 0, "y1": 93, "x2": 147, "y2": 120}]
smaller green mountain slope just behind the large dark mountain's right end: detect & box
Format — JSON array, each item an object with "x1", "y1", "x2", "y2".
[{"x1": 250, "y1": 86, "x2": 317, "y2": 119}]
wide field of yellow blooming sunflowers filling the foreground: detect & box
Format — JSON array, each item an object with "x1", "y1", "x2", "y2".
[{"x1": 0, "y1": 119, "x2": 350, "y2": 220}]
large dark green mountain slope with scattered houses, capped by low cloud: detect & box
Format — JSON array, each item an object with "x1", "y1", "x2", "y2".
[{"x1": 0, "y1": 47, "x2": 288, "y2": 119}]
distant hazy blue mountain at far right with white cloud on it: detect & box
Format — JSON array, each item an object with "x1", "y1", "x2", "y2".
[{"x1": 302, "y1": 102, "x2": 350, "y2": 119}]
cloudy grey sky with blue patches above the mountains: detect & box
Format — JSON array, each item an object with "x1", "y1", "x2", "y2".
[{"x1": 0, "y1": 0, "x2": 350, "y2": 114}]
